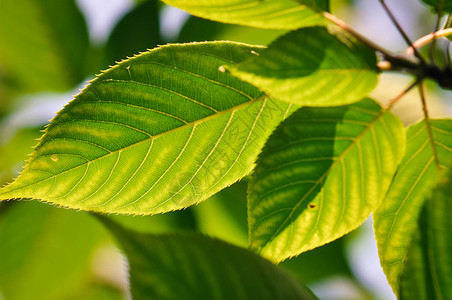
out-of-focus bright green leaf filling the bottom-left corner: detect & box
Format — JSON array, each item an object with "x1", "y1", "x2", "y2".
[{"x1": 0, "y1": 202, "x2": 109, "y2": 300}]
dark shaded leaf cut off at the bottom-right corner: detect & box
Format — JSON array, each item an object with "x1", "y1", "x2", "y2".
[{"x1": 400, "y1": 171, "x2": 452, "y2": 300}]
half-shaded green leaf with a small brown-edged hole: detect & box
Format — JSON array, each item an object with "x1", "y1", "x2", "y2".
[{"x1": 248, "y1": 99, "x2": 405, "y2": 261}]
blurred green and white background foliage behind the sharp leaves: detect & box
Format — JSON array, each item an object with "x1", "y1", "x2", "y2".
[{"x1": 0, "y1": 0, "x2": 451, "y2": 300}]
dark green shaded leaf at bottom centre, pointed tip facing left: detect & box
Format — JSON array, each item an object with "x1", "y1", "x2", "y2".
[{"x1": 101, "y1": 218, "x2": 315, "y2": 300}]
